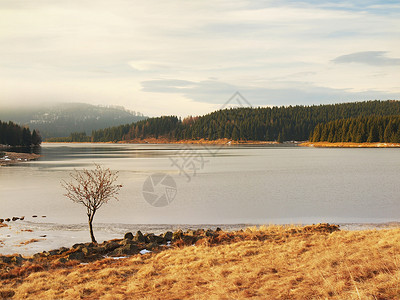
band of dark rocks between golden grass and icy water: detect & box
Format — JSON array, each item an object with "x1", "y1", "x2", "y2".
[{"x1": 0, "y1": 223, "x2": 339, "y2": 279}]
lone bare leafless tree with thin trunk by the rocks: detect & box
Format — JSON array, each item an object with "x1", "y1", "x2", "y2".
[{"x1": 61, "y1": 164, "x2": 122, "y2": 243}]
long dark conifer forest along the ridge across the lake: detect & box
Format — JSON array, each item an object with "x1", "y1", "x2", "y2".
[{"x1": 49, "y1": 100, "x2": 400, "y2": 142}]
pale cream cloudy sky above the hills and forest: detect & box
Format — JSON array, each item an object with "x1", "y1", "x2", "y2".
[{"x1": 0, "y1": 0, "x2": 400, "y2": 116}]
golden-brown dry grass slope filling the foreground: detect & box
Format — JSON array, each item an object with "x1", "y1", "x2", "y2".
[{"x1": 0, "y1": 226, "x2": 400, "y2": 299}]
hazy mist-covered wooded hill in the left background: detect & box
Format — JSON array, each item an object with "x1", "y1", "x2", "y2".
[{"x1": 0, "y1": 103, "x2": 147, "y2": 138}]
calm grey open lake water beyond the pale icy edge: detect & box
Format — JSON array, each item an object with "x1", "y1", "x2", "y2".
[{"x1": 0, "y1": 144, "x2": 400, "y2": 224}]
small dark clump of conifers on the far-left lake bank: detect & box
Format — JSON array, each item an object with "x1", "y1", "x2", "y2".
[{"x1": 0, "y1": 121, "x2": 42, "y2": 147}]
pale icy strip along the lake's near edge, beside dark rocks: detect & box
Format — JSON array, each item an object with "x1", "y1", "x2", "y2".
[{"x1": 0, "y1": 217, "x2": 400, "y2": 256}]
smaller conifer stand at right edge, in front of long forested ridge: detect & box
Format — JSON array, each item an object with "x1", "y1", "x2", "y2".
[{"x1": 310, "y1": 116, "x2": 400, "y2": 143}]
